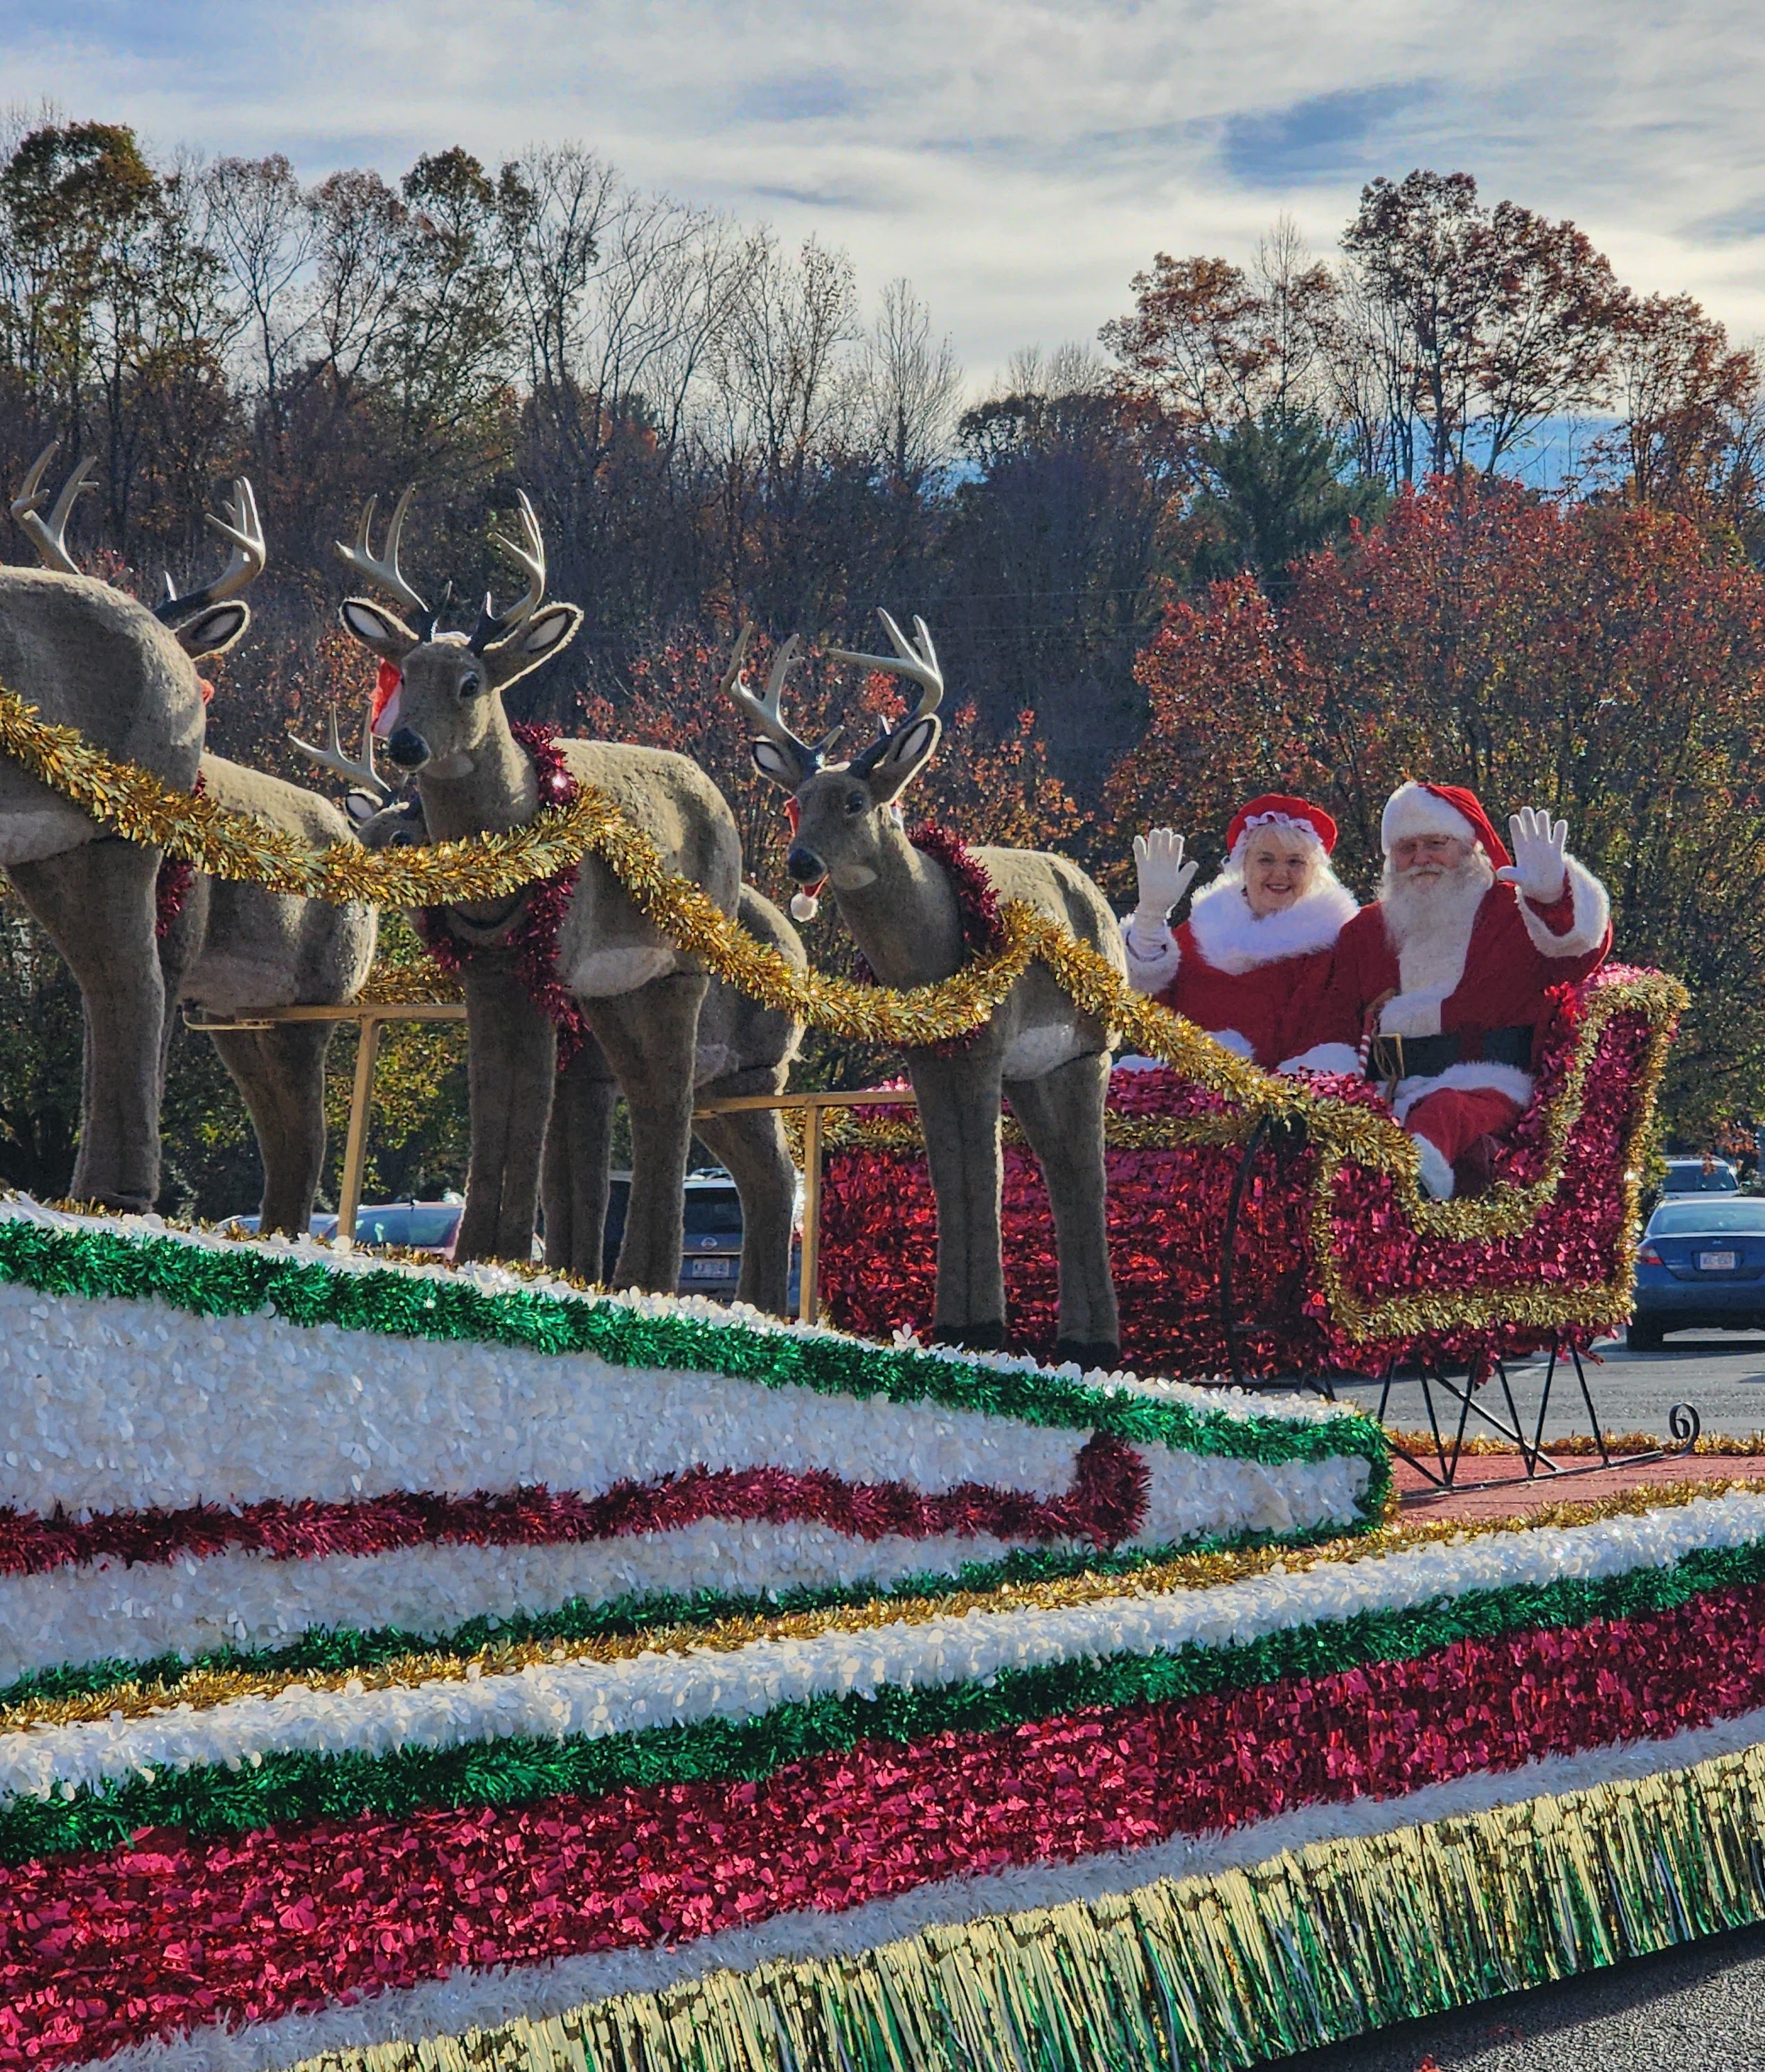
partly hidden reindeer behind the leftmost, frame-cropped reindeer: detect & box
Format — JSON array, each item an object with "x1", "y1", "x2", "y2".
[{"x1": 12, "y1": 447, "x2": 379, "y2": 1235}]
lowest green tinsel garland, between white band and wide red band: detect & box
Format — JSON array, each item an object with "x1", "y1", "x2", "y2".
[{"x1": 13, "y1": 1542, "x2": 1765, "y2": 1863}]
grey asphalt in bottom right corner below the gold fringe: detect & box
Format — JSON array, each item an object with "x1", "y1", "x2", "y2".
[{"x1": 1266, "y1": 1927, "x2": 1765, "y2": 2072}]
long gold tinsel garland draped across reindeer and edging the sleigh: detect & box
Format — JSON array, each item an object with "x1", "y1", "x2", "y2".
[{"x1": 0, "y1": 686, "x2": 1686, "y2": 1339}]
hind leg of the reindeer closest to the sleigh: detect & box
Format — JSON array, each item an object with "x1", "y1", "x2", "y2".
[{"x1": 1005, "y1": 1051, "x2": 1121, "y2": 1368}]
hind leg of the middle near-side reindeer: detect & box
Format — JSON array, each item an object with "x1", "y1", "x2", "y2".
[{"x1": 582, "y1": 972, "x2": 706, "y2": 1295}]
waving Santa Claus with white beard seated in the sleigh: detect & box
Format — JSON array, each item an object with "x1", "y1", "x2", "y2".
[{"x1": 1293, "y1": 783, "x2": 1612, "y2": 1199}]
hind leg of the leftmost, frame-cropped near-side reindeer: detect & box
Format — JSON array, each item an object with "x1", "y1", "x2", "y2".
[{"x1": 8, "y1": 839, "x2": 165, "y2": 1210}]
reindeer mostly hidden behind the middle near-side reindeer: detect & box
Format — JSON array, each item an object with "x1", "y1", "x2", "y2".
[{"x1": 327, "y1": 700, "x2": 808, "y2": 1316}]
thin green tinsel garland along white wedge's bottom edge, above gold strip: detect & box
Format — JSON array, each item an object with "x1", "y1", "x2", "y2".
[{"x1": 0, "y1": 1525, "x2": 1347, "y2": 1709}]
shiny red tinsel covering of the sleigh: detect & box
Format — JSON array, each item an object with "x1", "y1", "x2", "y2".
[{"x1": 821, "y1": 967, "x2": 1651, "y2": 1376}]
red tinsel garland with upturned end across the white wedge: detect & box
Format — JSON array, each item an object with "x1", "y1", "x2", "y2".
[{"x1": 0, "y1": 1431, "x2": 1145, "y2": 1575}]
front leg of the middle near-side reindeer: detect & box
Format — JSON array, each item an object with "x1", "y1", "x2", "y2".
[{"x1": 454, "y1": 953, "x2": 557, "y2": 1260}]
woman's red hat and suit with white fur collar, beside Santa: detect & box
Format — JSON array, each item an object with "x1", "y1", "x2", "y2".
[{"x1": 1123, "y1": 796, "x2": 1357, "y2": 1069}]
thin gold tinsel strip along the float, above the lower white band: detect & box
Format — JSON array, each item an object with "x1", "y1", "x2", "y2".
[{"x1": 0, "y1": 1483, "x2": 1765, "y2": 1732}]
